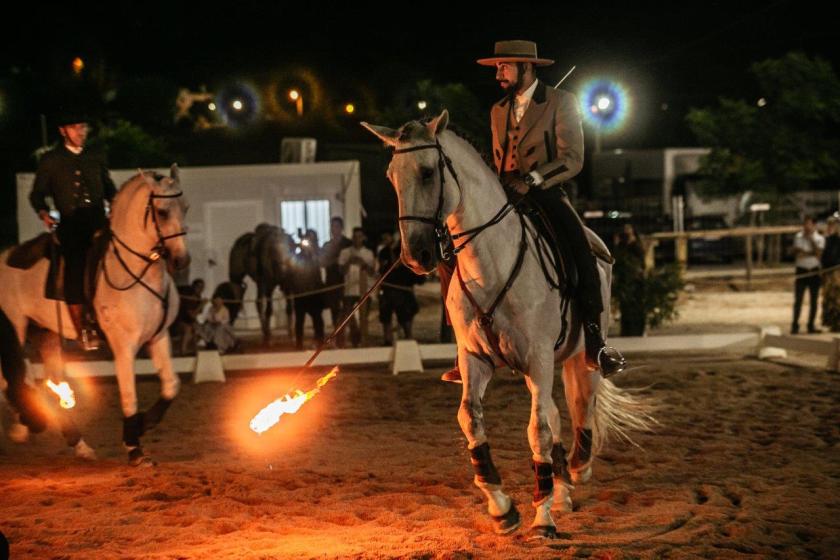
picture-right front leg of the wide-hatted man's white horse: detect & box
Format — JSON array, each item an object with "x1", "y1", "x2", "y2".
[{"x1": 525, "y1": 348, "x2": 565, "y2": 538}]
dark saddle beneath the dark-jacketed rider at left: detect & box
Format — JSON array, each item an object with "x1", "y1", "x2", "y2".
[{"x1": 6, "y1": 229, "x2": 111, "y2": 302}]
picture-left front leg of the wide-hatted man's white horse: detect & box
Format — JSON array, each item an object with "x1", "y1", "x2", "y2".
[{"x1": 458, "y1": 347, "x2": 521, "y2": 534}]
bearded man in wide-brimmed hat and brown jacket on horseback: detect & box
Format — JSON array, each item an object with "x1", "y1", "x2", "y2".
[{"x1": 442, "y1": 41, "x2": 626, "y2": 383}]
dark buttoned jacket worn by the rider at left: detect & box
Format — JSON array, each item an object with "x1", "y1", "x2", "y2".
[{"x1": 29, "y1": 144, "x2": 117, "y2": 221}]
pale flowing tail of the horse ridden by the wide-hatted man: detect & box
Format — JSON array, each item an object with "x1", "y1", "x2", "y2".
[{"x1": 592, "y1": 379, "x2": 659, "y2": 455}]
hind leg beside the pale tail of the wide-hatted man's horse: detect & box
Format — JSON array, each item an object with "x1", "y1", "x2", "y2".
[{"x1": 563, "y1": 352, "x2": 600, "y2": 482}]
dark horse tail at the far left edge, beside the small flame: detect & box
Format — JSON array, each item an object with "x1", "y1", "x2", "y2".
[{"x1": 0, "y1": 309, "x2": 47, "y2": 433}]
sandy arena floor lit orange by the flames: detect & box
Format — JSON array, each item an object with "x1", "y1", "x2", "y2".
[{"x1": 0, "y1": 355, "x2": 840, "y2": 559}]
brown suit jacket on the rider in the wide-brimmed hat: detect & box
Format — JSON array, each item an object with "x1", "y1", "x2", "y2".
[{"x1": 490, "y1": 82, "x2": 583, "y2": 189}]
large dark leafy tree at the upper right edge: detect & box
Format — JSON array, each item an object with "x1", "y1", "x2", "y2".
[{"x1": 686, "y1": 52, "x2": 840, "y2": 195}]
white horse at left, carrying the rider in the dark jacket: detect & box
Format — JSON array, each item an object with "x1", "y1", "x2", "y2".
[{"x1": 0, "y1": 165, "x2": 189, "y2": 466}]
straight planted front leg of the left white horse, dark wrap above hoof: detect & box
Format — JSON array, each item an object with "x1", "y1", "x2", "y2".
[{"x1": 108, "y1": 340, "x2": 154, "y2": 467}]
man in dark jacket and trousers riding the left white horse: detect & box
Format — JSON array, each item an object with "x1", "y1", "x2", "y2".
[{"x1": 29, "y1": 106, "x2": 117, "y2": 350}]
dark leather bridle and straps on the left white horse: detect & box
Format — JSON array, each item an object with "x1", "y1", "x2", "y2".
[{"x1": 101, "y1": 179, "x2": 187, "y2": 338}]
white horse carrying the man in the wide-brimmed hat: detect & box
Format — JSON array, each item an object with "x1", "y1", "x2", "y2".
[{"x1": 362, "y1": 111, "x2": 652, "y2": 538}]
